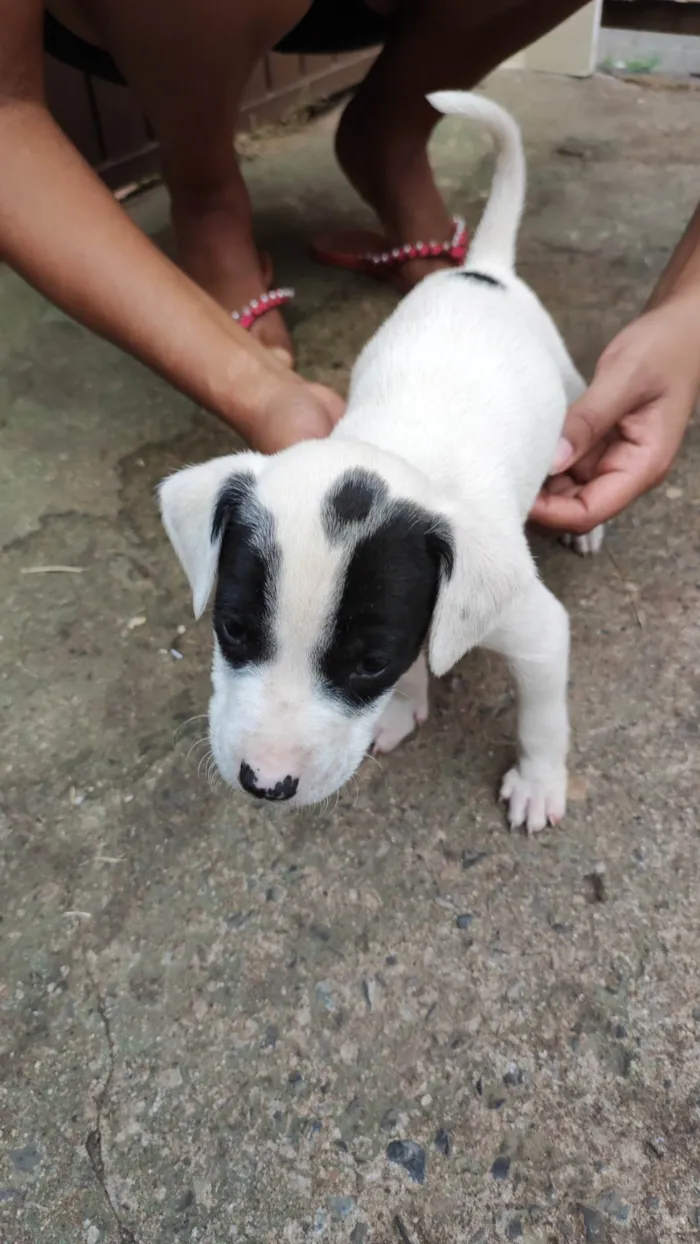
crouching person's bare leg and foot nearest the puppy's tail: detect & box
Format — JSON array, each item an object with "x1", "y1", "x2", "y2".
[{"x1": 336, "y1": 0, "x2": 583, "y2": 289}]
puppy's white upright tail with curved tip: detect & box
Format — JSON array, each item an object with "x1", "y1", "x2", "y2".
[{"x1": 428, "y1": 91, "x2": 526, "y2": 270}]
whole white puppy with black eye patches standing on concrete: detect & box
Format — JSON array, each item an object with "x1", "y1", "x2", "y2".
[{"x1": 160, "y1": 92, "x2": 599, "y2": 832}]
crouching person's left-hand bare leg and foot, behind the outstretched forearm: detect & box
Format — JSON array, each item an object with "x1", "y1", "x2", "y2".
[{"x1": 75, "y1": 0, "x2": 307, "y2": 361}]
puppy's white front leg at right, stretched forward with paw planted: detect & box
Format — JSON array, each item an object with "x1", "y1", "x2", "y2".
[{"x1": 484, "y1": 582, "x2": 568, "y2": 833}]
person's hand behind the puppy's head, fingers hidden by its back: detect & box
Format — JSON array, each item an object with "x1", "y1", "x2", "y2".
[{"x1": 246, "y1": 372, "x2": 346, "y2": 454}]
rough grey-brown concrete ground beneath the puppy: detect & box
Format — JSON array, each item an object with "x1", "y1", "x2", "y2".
[{"x1": 0, "y1": 73, "x2": 700, "y2": 1244}]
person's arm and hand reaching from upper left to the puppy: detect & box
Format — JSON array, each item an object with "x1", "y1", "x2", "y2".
[{"x1": 0, "y1": 0, "x2": 342, "y2": 452}]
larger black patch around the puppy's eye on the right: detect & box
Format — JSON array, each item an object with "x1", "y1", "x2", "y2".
[{"x1": 316, "y1": 501, "x2": 454, "y2": 710}]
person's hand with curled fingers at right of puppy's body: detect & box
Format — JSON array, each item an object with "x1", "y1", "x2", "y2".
[{"x1": 531, "y1": 298, "x2": 700, "y2": 534}]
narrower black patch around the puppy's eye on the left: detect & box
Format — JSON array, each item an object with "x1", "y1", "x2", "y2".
[{"x1": 211, "y1": 473, "x2": 280, "y2": 669}]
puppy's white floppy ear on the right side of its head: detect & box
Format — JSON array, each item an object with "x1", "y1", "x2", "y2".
[{"x1": 428, "y1": 515, "x2": 537, "y2": 677}]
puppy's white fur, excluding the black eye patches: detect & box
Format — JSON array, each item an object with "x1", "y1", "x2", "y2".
[{"x1": 160, "y1": 92, "x2": 599, "y2": 831}]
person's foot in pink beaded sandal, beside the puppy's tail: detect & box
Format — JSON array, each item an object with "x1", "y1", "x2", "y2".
[{"x1": 336, "y1": 91, "x2": 453, "y2": 294}]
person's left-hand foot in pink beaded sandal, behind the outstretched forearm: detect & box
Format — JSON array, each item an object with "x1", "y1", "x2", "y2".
[{"x1": 172, "y1": 178, "x2": 293, "y2": 367}]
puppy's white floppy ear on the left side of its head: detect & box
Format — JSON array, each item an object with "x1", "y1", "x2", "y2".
[{"x1": 158, "y1": 453, "x2": 264, "y2": 618}]
